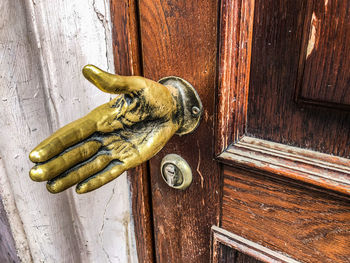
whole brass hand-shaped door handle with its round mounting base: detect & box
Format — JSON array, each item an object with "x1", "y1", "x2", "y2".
[{"x1": 29, "y1": 65, "x2": 202, "y2": 193}]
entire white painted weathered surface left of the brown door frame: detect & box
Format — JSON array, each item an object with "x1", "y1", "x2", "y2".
[{"x1": 0, "y1": 0, "x2": 137, "y2": 262}]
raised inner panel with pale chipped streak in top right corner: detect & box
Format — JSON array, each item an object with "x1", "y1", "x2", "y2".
[{"x1": 297, "y1": 0, "x2": 350, "y2": 110}]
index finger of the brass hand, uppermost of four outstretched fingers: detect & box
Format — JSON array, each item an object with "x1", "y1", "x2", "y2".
[{"x1": 29, "y1": 117, "x2": 96, "y2": 163}]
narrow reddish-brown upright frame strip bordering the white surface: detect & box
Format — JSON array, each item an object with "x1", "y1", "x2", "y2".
[{"x1": 111, "y1": 0, "x2": 154, "y2": 262}]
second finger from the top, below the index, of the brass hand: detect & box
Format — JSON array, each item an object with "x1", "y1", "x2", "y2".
[{"x1": 29, "y1": 141, "x2": 102, "y2": 182}]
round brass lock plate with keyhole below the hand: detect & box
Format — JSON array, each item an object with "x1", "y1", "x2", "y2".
[{"x1": 160, "y1": 154, "x2": 192, "y2": 190}]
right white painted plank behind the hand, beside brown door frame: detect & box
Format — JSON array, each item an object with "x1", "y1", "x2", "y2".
[{"x1": 27, "y1": 0, "x2": 132, "y2": 262}]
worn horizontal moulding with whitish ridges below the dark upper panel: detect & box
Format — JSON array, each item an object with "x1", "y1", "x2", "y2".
[{"x1": 218, "y1": 136, "x2": 350, "y2": 195}]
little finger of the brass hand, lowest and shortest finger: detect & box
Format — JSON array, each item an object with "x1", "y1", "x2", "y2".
[{"x1": 76, "y1": 160, "x2": 126, "y2": 194}]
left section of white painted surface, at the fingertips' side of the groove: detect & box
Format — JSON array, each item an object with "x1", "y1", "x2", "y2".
[{"x1": 0, "y1": 0, "x2": 80, "y2": 262}]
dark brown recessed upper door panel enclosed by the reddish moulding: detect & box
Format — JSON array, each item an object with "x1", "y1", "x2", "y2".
[{"x1": 247, "y1": 0, "x2": 350, "y2": 158}]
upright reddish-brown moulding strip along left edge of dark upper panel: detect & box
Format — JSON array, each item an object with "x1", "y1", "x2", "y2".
[{"x1": 215, "y1": 0, "x2": 255, "y2": 155}]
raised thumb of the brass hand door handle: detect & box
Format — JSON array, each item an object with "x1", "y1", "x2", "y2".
[{"x1": 83, "y1": 65, "x2": 145, "y2": 94}]
